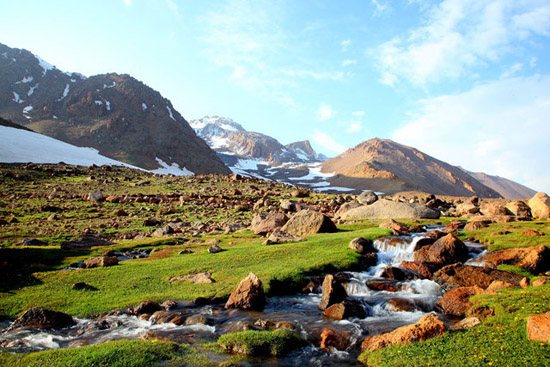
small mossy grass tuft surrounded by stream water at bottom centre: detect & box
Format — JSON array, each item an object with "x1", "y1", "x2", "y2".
[{"x1": 218, "y1": 329, "x2": 304, "y2": 357}]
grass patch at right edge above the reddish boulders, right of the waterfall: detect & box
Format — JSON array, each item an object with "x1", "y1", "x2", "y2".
[{"x1": 460, "y1": 221, "x2": 550, "y2": 251}]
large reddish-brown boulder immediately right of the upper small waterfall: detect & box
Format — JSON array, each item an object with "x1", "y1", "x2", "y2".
[{"x1": 414, "y1": 234, "x2": 469, "y2": 265}]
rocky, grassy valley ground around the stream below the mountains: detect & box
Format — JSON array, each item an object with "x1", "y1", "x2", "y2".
[{"x1": 0, "y1": 164, "x2": 550, "y2": 365}]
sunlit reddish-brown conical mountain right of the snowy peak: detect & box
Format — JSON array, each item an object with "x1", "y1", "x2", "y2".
[{"x1": 321, "y1": 138, "x2": 500, "y2": 197}]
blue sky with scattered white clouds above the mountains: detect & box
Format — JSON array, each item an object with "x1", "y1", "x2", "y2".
[{"x1": 0, "y1": 0, "x2": 550, "y2": 193}]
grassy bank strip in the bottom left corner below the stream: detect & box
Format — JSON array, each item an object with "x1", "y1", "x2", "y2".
[{"x1": 0, "y1": 340, "x2": 192, "y2": 367}]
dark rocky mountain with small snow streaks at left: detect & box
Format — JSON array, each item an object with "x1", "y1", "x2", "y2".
[{"x1": 0, "y1": 44, "x2": 230, "y2": 173}]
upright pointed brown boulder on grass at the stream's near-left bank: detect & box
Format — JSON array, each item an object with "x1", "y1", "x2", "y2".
[{"x1": 225, "y1": 272, "x2": 266, "y2": 311}]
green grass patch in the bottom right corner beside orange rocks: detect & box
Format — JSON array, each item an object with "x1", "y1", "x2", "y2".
[{"x1": 359, "y1": 286, "x2": 550, "y2": 367}]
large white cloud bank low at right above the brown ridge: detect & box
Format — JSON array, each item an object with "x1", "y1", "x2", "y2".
[{"x1": 392, "y1": 75, "x2": 550, "y2": 193}]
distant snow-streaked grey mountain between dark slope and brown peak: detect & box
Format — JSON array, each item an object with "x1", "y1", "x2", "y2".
[{"x1": 189, "y1": 116, "x2": 322, "y2": 167}]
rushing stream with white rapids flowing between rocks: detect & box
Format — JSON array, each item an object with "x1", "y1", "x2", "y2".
[{"x1": 0, "y1": 226, "x2": 483, "y2": 366}]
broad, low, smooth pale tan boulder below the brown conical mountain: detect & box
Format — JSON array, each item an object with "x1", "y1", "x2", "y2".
[{"x1": 341, "y1": 200, "x2": 440, "y2": 219}]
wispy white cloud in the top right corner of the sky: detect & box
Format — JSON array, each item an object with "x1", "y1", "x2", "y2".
[{"x1": 373, "y1": 0, "x2": 550, "y2": 86}]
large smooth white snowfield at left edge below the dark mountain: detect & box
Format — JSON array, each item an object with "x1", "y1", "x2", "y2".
[{"x1": 0, "y1": 126, "x2": 137, "y2": 168}]
